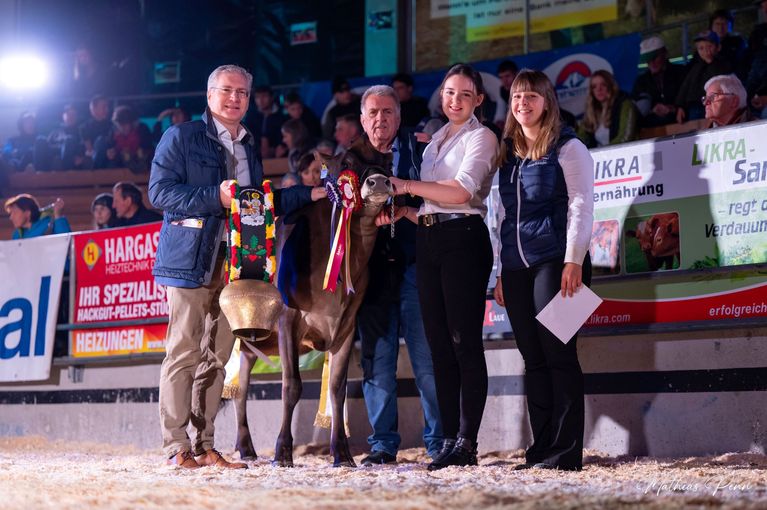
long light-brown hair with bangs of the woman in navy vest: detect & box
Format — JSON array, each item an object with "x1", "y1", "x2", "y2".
[{"x1": 498, "y1": 69, "x2": 562, "y2": 166}]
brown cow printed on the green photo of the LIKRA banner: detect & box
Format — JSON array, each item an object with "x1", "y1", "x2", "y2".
[{"x1": 626, "y1": 213, "x2": 679, "y2": 271}]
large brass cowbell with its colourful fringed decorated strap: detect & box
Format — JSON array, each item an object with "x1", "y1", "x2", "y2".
[{"x1": 219, "y1": 188, "x2": 283, "y2": 342}]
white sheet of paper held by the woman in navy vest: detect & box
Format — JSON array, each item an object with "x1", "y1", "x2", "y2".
[{"x1": 535, "y1": 285, "x2": 602, "y2": 343}]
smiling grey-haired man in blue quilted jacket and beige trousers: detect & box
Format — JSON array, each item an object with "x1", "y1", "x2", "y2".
[{"x1": 149, "y1": 65, "x2": 325, "y2": 468}]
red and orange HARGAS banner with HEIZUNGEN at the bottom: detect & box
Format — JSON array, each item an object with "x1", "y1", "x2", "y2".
[{"x1": 70, "y1": 223, "x2": 168, "y2": 357}]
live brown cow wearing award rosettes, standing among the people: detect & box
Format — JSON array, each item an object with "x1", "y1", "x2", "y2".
[{"x1": 235, "y1": 137, "x2": 392, "y2": 467}]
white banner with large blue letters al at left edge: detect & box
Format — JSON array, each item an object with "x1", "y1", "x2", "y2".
[{"x1": 0, "y1": 234, "x2": 69, "y2": 382}]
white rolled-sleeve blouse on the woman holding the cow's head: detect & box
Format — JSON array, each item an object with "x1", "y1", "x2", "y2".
[{"x1": 418, "y1": 115, "x2": 498, "y2": 218}]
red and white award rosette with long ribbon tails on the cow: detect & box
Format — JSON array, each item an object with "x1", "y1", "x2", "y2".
[{"x1": 322, "y1": 170, "x2": 362, "y2": 294}]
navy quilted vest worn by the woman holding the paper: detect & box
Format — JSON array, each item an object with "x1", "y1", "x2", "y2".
[{"x1": 498, "y1": 126, "x2": 575, "y2": 270}]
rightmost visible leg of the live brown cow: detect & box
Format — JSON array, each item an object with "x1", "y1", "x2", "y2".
[{"x1": 328, "y1": 335, "x2": 357, "y2": 467}]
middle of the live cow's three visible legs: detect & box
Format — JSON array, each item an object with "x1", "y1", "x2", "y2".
[{"x1": 272, "y1": 309, "x2": 302, "y2": 467}]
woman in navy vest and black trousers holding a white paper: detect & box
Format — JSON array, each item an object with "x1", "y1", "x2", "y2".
[{"x1": 494, "y1": 70, "x2": 594, "y2": 470}]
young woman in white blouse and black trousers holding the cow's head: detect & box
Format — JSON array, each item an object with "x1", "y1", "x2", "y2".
[{"x1": 379, "y1": 64, "x2": 498, "y2": 470}]
